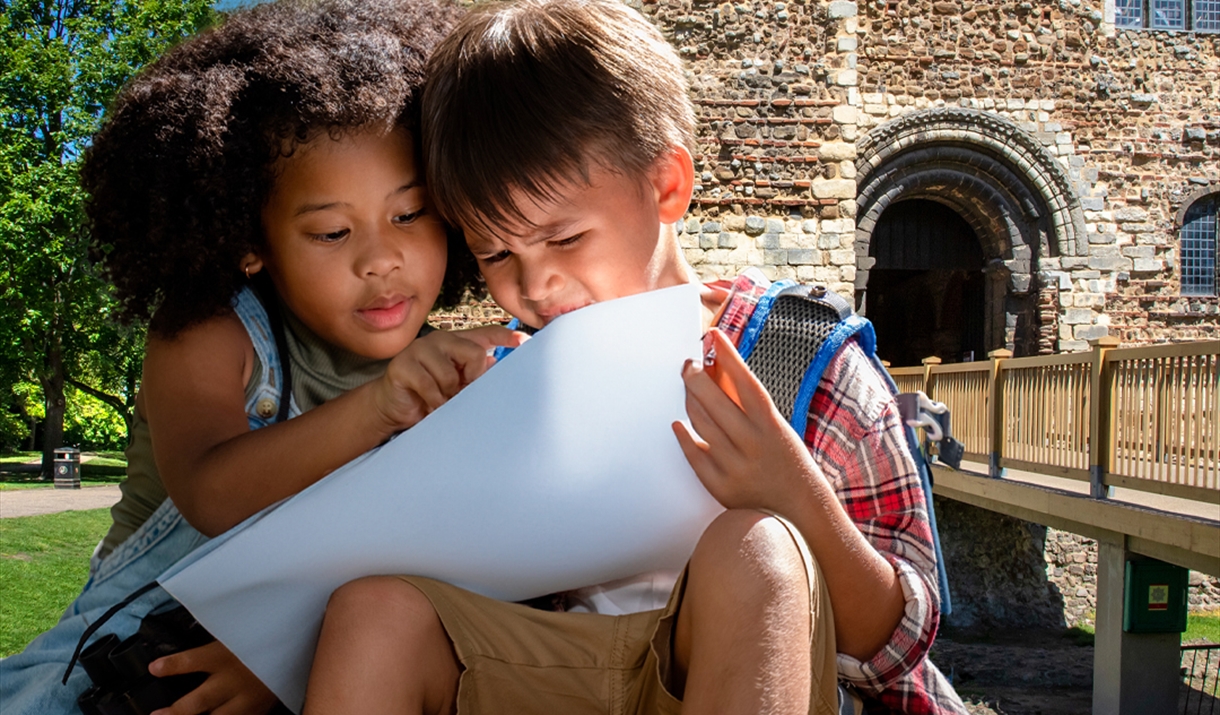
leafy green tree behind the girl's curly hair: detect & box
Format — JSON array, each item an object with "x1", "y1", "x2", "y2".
[{"x1": 0, "y1": 0, "x2": 215, "y2": 473}]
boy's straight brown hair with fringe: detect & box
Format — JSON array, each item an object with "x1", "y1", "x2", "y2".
[{"x1": 422, "y1": 0, "x2": 694, "y2": 229}]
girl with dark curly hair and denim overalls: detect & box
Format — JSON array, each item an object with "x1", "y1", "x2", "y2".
[{"x1": 0, "y1": 0, "x2": 517, "y2": 715}]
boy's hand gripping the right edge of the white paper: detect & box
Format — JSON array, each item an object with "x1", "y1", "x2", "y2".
[{"x1": 673, "y1": 329, "x2": 825, "y2": 515}]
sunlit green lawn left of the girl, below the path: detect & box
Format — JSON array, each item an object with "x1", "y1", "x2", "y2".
[{"x1": 0, "y1": 509, "x2": 110, "y2": 656}]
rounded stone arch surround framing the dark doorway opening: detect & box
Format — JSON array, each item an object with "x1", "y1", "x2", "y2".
[{"x1": 855, "y1": 109, "x2": 1088, "y2": 354}]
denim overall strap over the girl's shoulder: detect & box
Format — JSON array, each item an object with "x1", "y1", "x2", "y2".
[{"x1": 233, "y1": 286, "x2": 300, "y2": 429}]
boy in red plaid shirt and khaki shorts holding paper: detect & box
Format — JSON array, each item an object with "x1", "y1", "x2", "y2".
[{"x1": 305, "y1": 0, "x2": 965, "y2": 715}]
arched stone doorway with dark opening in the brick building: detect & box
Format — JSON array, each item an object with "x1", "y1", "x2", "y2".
[{"x1": 855, "y1": 107, "x2": 1087, "y2": 365}]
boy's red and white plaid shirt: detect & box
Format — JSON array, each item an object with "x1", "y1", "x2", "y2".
[{"x1": 717, "y1": 270, "x2": 966, "y2": 715}]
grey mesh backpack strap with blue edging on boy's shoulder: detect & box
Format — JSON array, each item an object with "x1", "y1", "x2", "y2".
[{"x1": 739, "y1": 282, "x2": 952, "y2": 615}]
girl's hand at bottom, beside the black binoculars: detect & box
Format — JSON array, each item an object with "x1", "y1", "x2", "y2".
[{"x1": 149, "y1": 641, "x2": 277, "y2": 715}]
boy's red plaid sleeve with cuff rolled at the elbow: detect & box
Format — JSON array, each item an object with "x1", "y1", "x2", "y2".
[{"x1": 805, "y1": 342, "x2": 939, "y2": 693}]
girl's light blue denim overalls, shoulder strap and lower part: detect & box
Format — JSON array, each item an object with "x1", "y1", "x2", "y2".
[{"x1": 0, "y1": 288, "x2": 299, "y2": 715}]
